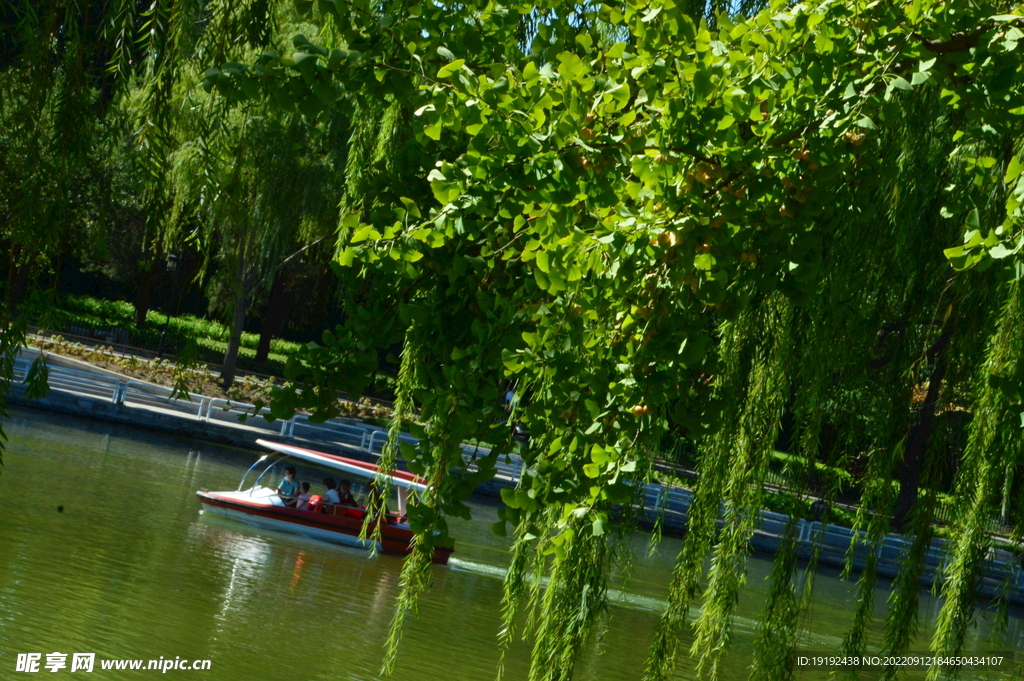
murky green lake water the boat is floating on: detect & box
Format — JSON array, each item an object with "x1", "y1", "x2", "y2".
[{"x1": 0, "y1": 411, "x2": 1024, "y2": 681}]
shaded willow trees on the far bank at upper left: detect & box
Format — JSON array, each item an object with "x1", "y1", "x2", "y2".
[{"x1": 0, "y1": 1, "x2": 349, "y2": 385}]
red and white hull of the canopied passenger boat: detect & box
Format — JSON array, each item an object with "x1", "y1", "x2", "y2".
[{"x1": 196, "y1": 492, "x2": 452, "y2": 565}]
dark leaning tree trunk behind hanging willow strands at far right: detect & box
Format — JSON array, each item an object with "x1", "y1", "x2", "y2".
[{"x1": 892, "y1": 329, "x2": 952, "y2": 531}]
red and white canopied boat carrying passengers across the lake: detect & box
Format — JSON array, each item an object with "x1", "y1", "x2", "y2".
[{"x1": 196, "y1": 439, "x2": 453, "y2": 565}]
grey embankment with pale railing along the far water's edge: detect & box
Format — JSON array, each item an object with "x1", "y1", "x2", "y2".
[{"x1": 11, "y1": 349, "x2": 1024, "y2": 605}]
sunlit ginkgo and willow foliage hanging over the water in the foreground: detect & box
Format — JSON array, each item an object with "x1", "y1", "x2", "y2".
[{"x1": 7, "y1": 0, "x2": 1024, "y2": 680}]
